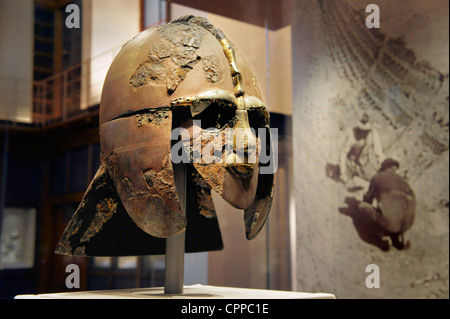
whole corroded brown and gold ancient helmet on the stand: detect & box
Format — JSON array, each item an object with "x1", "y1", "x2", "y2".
[{"x1": 57, "y1": 16, "x2": 274, "y2": 255}]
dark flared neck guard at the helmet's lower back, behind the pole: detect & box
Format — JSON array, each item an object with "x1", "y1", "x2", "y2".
[{"x1": 56, "y1": 165, "x2": 223, "y2": 256}]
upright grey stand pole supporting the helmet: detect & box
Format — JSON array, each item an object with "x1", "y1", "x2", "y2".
[{"x1": 164, "y1": 164, "x2": 187, "y2": 294}]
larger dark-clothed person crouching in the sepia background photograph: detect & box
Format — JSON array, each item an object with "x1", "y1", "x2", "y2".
[{"x1": 358, "y1": 158, "x2": 416, "y2": 249}]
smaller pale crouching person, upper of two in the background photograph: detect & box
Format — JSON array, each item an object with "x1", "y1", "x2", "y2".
[{"x1": 339, "y1": 113, "x2": 384, "y2": 190}]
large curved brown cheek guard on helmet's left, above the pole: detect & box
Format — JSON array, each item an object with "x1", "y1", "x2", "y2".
[{"x1": 100, "y1": 110, "x2": 186, "y2": 238}]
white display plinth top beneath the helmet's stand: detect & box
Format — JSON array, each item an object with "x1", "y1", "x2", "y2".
[{"x1": 15, "y1": 284, "x2": 335, "y2": 299}]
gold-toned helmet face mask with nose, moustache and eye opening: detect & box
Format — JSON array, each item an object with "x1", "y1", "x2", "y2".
[{"x1": 172, "y1": 97, "x2": 264, "y2": 209}]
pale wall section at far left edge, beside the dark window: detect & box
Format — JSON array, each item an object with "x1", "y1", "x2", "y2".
[{"x1": 0, "y1": 0, "x2": 34, "y2": 122}]
